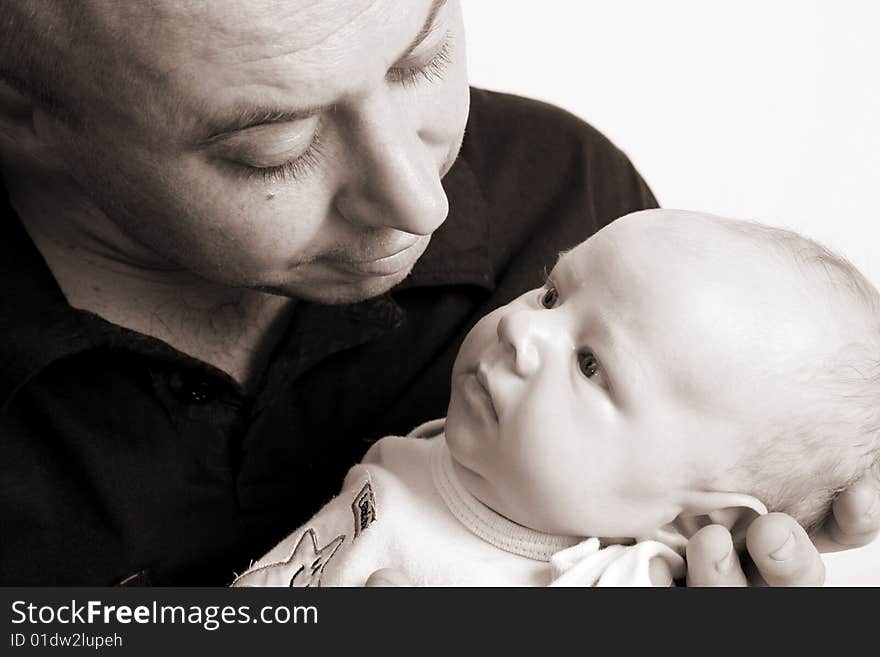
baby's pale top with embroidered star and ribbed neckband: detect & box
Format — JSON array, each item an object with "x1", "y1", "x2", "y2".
[{"x1": 233, "y1": 420, "x2": 684, "y2": 586}]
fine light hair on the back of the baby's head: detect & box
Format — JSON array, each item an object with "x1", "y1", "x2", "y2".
[{"x1": 721, "y1": 219, "x2": 880, "y2": 534}]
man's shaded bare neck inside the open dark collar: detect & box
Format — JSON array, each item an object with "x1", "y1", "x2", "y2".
[{"x1": 7, "y1": 170, "x2": 293, "y2": 388}]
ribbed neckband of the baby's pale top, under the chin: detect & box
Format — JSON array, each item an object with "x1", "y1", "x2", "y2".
[{"x1": 431, "y1": 434, "x2": 584, "y2": 561}]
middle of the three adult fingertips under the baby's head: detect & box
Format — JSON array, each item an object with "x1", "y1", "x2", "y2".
[{"x1": 746, "y1": 513, "x2": 825, "y2": 586}]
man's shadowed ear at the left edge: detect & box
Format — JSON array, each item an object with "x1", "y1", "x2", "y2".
[{"x1": 0, "y1": 80, "x2": 64, "y2": 166}]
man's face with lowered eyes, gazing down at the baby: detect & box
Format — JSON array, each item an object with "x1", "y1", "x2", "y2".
[{"x1": 41, "y1": 0, "x2": 468, "y2": 303}]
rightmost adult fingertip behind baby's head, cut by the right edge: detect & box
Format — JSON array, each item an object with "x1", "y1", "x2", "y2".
[{"x1": 825, "y1": 475, "x2": 880, "y2": 549}]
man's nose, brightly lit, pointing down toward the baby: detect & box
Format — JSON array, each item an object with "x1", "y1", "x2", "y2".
[{"x1": 336, "y1": 94, "x2": 449, "y2": 235}]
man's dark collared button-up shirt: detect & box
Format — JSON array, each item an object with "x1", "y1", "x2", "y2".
[{"x1": 0, "y1": 90, "x2": 656, "y2": 585}]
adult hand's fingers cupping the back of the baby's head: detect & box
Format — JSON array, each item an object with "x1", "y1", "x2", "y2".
[{"x1": 687, "y1": 472, "x2": 880, "y2": 586}]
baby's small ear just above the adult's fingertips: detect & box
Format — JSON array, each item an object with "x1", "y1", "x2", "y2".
[{"x1": 676, "y1": 491, "x2": 767, "y2": 543}]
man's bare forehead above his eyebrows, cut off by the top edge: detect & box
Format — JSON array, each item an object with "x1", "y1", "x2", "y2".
[{"x1": 71, "y1": 0, "x2": 444, "y2": 137}]
